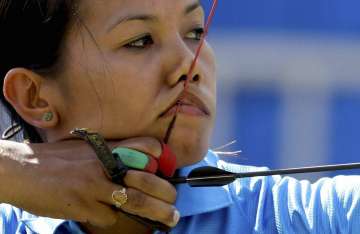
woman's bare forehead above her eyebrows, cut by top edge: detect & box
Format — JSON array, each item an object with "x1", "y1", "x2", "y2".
[{"x1": 79, "y1": 0, "x2": 199, "y2": 29}]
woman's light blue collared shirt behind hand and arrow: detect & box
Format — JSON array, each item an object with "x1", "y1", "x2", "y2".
[{"x1": 0, "y1": 151, "x2": 360, "y2": 234}]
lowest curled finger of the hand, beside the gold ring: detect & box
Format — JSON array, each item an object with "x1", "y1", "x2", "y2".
[{"x1": 121, "y1": 188, "x2": 180, "y2": 227}]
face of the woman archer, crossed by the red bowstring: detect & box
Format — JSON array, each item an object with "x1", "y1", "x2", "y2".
[{"x1": 49, "y1": 0, "x2": 216, "y2": 167}]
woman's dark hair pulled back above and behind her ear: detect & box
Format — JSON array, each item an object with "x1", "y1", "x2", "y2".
[{"x1": 0, "y1": 0, "x2": 73, "y2": 142}]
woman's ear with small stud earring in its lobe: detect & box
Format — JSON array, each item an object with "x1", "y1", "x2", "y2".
[{"x1": 3, "y1": 68, "x2": 59, "y2": 129}]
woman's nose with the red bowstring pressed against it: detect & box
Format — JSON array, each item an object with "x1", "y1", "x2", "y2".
[{"x1": 166, "y1": 41, "x2": 202, "y2": 87}]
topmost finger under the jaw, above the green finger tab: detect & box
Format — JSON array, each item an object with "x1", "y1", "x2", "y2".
[{"x1": 111, "y1": 137, "x2": 162, "y2": 158}]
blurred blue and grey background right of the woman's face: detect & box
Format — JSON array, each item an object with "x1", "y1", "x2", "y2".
[{"x1": 202, "y1": 0, "x2": 360, "y2": 179}]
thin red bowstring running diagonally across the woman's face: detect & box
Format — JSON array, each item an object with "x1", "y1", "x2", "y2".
[{"x1": 164, "y1": 0, "x2": 218, "y2": 144}]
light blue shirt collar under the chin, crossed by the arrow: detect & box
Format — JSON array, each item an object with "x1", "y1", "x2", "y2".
[{"x1": 176, "y1": 151, "x2": 233, "y2": 217}]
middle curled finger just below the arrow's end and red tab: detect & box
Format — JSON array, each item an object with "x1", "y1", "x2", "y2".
[{"x1": 124, "y1": 170, "x2": 177, "y2": 203}]
